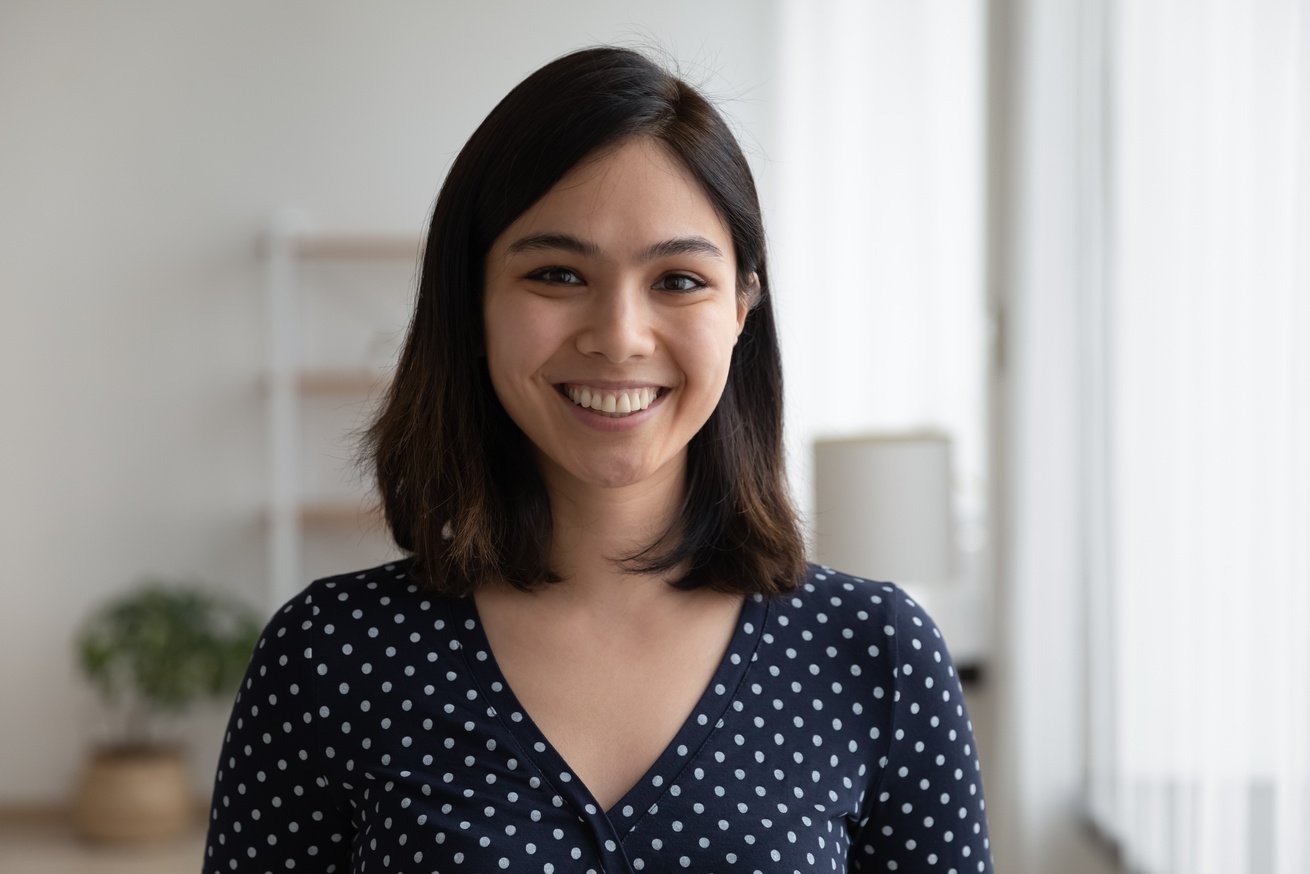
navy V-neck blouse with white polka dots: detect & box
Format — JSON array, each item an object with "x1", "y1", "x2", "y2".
[{"x1": 204, "y1": 562, "x2": 992, "y2": 874}]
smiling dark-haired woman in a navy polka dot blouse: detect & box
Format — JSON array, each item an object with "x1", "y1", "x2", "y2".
[{"x1": 206, "y1": 48, "x2": 990, "y2": 873}]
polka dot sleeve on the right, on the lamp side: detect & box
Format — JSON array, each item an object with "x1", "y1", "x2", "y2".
[{"x1": 850, "y1": 586, "x2": 993, "y2": 874}]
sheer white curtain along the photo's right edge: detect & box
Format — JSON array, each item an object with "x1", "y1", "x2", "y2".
[{"x1": 1085, "y1": 0, "x2": 1310, "y2": 874}]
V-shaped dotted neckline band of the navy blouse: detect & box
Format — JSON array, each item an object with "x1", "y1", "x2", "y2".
[{"x1": 456, "y1": 595, "x2": 769, "y2": 840}]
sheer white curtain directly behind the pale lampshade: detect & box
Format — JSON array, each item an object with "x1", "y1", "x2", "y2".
[{"x1": 764, "y1": 0, "x2": 989, "y2": 662}]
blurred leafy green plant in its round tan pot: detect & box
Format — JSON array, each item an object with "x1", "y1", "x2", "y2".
[{"x1": 73, "y1": 580, "x2": 259, "y2": 841}]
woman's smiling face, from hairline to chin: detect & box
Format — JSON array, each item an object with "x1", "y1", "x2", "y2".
[{"x1": 483, "y1": 139, "x2": 747, "y2": 490}]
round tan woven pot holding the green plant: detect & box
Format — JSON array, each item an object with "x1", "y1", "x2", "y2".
[{"x1": 73, "y1": 747, "x2": 195, "y2": 843}]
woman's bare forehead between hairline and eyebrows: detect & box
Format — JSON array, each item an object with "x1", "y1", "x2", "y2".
[{"x1": 491, "y1": 138, "x2": 732, "y2": 256}]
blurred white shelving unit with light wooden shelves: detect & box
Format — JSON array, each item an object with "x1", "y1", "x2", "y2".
[{"x1": 263, "y1": 212, "x2": 421, "y2": 604}]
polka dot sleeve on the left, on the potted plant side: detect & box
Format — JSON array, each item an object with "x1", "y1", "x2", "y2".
[{"x1": 203, "y1": 588, "x2": 354, "y2": 874}]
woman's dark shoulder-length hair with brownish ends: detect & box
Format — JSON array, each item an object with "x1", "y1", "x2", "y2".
[{"x1": 364, "y1": 47, "x2": 804, "y2": 595}]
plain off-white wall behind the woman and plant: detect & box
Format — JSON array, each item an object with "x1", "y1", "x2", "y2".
[{"x1": 0, "y1": 0, "x2": 776, "y2": 803}]
